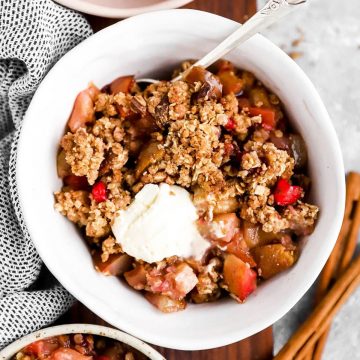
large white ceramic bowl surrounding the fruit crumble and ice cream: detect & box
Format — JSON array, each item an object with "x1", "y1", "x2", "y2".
[{"x1": 17, "y1": 10, "x2": 345, "y2": 350}]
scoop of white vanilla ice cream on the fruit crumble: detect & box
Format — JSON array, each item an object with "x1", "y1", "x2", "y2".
[{"x1": 112, "y1": 183, "x2": 210, "y2": 263}]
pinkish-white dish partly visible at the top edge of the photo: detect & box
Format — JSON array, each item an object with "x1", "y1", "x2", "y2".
[{"x1": 55, "y1": 0, "x2": 192, "y2": 18}]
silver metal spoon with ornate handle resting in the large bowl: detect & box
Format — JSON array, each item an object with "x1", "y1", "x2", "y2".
[{"x1": 136, "y1": 0, "x2": 307, "y2": 84}]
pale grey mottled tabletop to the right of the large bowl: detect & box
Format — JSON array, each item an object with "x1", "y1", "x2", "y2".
[{"x1": 258, "y1": 0, "x2": 360, "y2": 360}]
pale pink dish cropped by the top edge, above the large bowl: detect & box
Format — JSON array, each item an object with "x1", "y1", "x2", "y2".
[{"x1": 55, "y1": 0, "x2": 193, "y2": 19}]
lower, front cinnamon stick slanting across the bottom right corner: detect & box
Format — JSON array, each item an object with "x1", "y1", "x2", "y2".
[{"x1": 274, "y1": 253, "x2": 360, "y2": 360}]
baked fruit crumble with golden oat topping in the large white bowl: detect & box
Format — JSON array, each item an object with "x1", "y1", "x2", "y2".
[{"x1": 55, "y1": 60, "x2": 319, "y2": 312}]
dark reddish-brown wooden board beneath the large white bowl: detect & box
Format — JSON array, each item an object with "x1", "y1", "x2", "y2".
[{"x1": 58, "y1": 0, "x2": 273, "y2": 360}]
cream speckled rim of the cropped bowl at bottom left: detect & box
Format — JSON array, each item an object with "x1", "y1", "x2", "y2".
[{"x1": 0, "y1": 324, "x2": 165, "y2": 360}]
